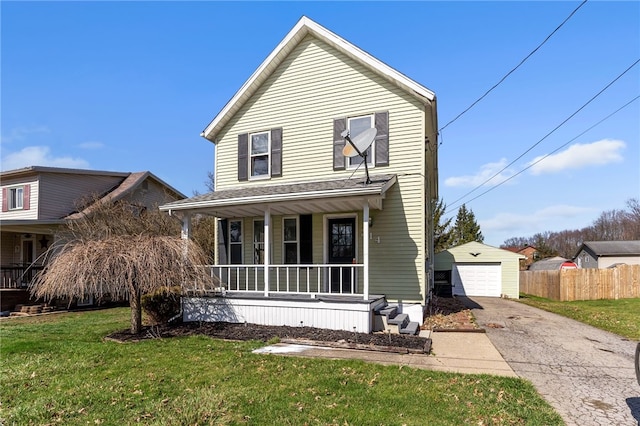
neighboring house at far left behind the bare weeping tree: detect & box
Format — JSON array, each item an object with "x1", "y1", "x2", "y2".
[{"x1": 0, "y1": 166, "x2": 185, "y2": 311}]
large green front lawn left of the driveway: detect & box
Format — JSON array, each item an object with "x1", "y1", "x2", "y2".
[{"x1": 0, "y1": 308, "x2": 562, "y2": 425}]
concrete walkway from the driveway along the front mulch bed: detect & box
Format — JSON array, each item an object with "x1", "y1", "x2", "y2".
[{"x1": 255, "y1": 332, "x2": 517, "y2": 377}]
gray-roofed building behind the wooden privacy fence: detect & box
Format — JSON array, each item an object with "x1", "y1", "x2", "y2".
[{"x1": 573, "y1": 241, "x2": 640, "y2": 269}]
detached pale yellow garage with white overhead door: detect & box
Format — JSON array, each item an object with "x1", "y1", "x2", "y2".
[{"x1": 435, "y1": 242, "x2": 524, "y2": 299}]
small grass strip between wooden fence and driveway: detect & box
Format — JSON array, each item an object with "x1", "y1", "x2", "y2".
[{"x1": 519, "y1": 294, "x2": 640, "y2": 340}]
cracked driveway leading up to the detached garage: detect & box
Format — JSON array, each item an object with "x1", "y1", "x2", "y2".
[{"x1": 465, "y1": 297, "x2": 640, "y2": 426}]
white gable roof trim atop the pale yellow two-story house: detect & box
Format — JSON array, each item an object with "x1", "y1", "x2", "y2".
[{"x1": 200, "y1": 16, "x2": 436, "y2": 143}]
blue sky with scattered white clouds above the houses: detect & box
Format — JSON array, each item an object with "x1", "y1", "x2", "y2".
[{"x1": 0, "y1": 0, "x2": 640, "y2": 245}]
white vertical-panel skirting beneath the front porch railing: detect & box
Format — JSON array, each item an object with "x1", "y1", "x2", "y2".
[{"x1": 182, "y1": 296, "x2": 385, "y2": 333}]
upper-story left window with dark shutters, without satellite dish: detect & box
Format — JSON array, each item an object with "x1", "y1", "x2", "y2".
[{"x1": 238, "y1": 128, "x2": 282, "y2": 181}]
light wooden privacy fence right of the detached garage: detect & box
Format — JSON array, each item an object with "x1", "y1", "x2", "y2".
[{"x1": 520, "y1": 265, "x2": 640, "y2": 302}]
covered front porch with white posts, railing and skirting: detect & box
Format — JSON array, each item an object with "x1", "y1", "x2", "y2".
[{"x1": 160, "y1": 175, "x2": 404, "y2": 333}]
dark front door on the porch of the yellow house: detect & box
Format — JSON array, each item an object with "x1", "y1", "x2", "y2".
[{"x1": 327, "y1": 217, "x2": 356, "y2": 293}]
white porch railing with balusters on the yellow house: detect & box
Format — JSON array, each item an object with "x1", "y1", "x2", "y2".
[{"x1": 206, "y1": 264, "x2": 364, "y2": 297}]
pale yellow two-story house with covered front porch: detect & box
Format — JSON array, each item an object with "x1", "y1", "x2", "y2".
[{"x1": 161, "y1": 17, "x2": 438, "y2": 332}]
